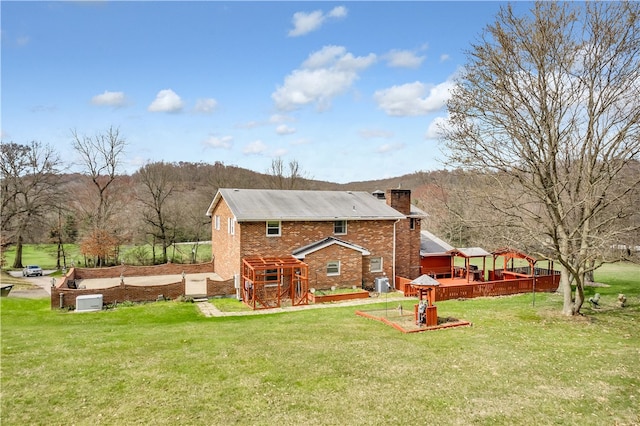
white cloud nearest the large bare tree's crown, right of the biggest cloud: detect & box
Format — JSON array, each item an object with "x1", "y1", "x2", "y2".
[{"x1": 373, "y1": 80, "x2": 453, "y2": 116}]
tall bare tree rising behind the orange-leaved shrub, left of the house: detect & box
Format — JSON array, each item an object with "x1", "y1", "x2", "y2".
[{"x1": 71, "y1": 127, "x2": 127, "y2": 265}]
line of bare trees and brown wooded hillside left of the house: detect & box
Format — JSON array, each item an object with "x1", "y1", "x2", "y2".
[{"x1": 0, "y1": 127, "x2": 321, "y2": 268}]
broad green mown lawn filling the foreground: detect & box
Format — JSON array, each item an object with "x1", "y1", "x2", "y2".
[{"x1": 0, "y1": 264, "x2": 640, "y2": 425}]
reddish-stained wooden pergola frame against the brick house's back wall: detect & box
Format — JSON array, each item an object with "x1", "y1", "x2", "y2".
[{"x1": 241, "y1": 256, "x2": 309, "y2": 309}]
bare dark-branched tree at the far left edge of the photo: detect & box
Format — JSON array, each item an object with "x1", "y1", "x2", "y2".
[{"x1": 0, "y1": 142, "x2": 61, "y2": 268}]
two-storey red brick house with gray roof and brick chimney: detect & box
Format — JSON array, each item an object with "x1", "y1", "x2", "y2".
[{"x1": 207, "y1": 188, "x2": 424, "y2": 302}]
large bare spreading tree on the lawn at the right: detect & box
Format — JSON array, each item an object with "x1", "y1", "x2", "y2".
[{"x1": 442, "y1": 2, "x2": 640, "y2": 315}]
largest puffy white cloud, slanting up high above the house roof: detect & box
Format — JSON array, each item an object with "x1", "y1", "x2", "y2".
[{"x1": 271, "y1": 46, "x2": 376, "y2": 110}]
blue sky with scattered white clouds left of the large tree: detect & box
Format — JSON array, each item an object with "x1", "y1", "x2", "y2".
[{"x1": 0, "y1": 1, "x2": 516, "y2": 183}]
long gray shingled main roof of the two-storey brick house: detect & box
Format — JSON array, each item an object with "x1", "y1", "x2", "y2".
[{"x1": 207, "y1": 188, "x2": 405, "y2": 222}]
